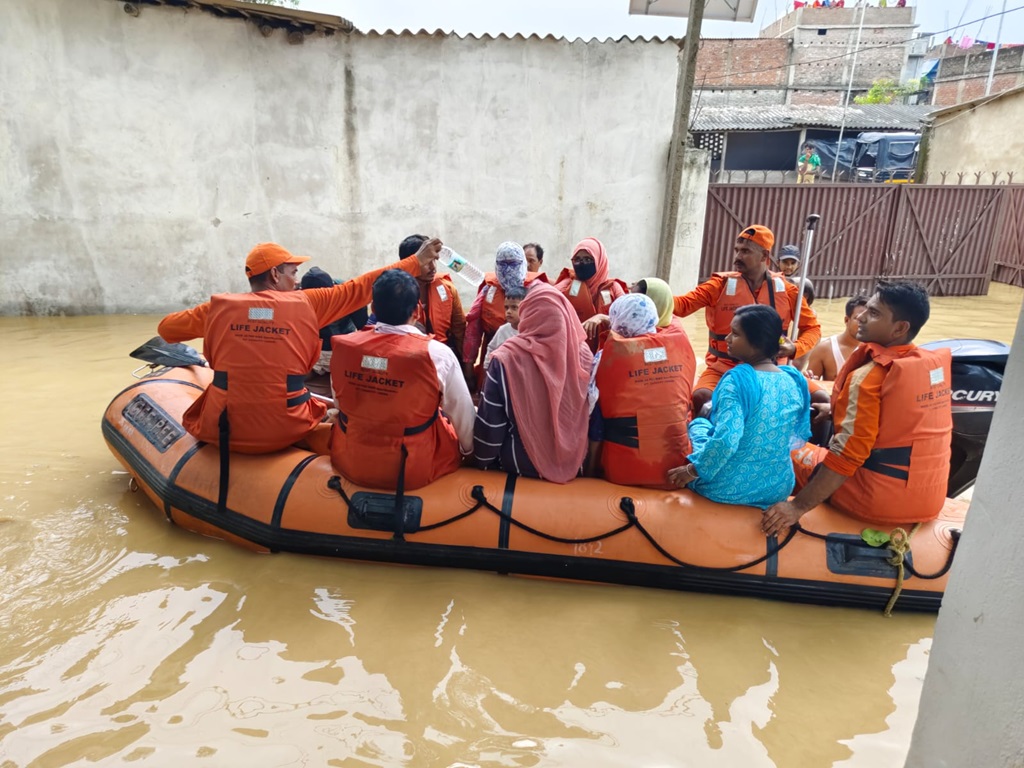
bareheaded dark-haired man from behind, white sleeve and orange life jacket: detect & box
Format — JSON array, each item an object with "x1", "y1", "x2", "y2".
[{"x1": 331, "y1": 269, "x2": 476, "y2": 493}]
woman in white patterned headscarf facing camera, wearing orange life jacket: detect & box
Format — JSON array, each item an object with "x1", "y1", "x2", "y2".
[{"x1": 462, "y1": 242, "x2": 548, "y2": 388}]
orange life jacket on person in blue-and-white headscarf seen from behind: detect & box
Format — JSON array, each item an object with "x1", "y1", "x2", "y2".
[{"x1": 597, "y1": 324, "x2": 696, "y2": 488}]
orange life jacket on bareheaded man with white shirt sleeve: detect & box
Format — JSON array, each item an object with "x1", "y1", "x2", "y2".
[{"x1": 331, "y1": 331, "x2": 461, "y2": 490}]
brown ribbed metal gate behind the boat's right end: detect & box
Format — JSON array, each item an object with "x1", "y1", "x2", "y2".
[{"x1": 700, "y1": 184, "x2": 1011, "y2": 297}]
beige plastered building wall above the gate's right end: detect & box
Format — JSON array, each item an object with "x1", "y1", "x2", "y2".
[{"x1": 923, "y1": 93, "x2": 1024, "y2": 184}]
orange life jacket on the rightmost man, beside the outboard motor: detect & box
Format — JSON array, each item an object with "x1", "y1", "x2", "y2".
[{"x1": 831, "y1": 344, "x2": 953, "y2": 524}]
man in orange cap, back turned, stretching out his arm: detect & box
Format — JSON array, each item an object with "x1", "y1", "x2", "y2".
[{"x1": 157, "y1": 240, "x2": 441, "y2": 454}]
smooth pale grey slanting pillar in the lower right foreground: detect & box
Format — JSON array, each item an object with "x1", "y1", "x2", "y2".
[{"x1": 906, "y1": 303, "x2": 1024, "y2": 768}]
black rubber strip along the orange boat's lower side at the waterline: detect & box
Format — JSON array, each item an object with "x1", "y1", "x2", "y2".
[{"x1": 102, "y1": 419, "x2": 942, "y2": 611}]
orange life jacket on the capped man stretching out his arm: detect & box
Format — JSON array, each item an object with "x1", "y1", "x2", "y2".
[{"x1": 181, "y1": 291, "x2": 327, "y2": 454}]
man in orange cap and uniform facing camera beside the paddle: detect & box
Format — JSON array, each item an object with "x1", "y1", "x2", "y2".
[{"x1": 675, "y1": 224, "x2": 821, "y2": 413}]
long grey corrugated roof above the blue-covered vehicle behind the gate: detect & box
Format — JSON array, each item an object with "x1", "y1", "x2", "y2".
[{"x1": 690, "y1": 104, "x2": 937, "y2": 131}]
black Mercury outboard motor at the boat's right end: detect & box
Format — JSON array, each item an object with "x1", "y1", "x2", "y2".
[{"x1": 922, "y1": 339, "x2": 1010, "y2": 499}]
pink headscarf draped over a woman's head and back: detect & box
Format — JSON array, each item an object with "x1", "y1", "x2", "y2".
[{"x1": 494, "y1": 283, "x2": 593, "y2": 482}]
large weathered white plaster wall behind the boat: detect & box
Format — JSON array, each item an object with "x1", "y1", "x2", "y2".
[{"x1": 0, "y1": 0, "x2": 702, "y2": 313}]
